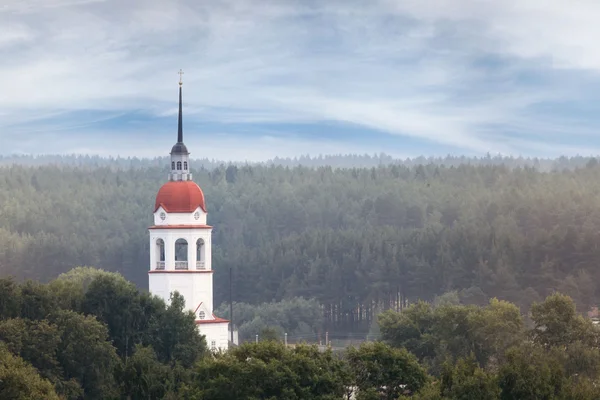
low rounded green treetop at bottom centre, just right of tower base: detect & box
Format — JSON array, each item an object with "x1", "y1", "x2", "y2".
[{"x1": 191, "y1": 341, "x2": 349, "y2": 400}]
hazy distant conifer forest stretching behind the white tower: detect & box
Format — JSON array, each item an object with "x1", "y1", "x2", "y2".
[{"x1": 0, "y1": 158, "x2": 600, "y2": 332}]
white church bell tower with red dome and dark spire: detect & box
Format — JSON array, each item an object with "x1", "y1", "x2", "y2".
[{"x1": 148, "y1": 71, "x2": 229, "y2": 350}]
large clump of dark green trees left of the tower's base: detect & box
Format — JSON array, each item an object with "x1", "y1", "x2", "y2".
[{"x1": 0, "y1": 268, "x2": 206, "y2": 400}]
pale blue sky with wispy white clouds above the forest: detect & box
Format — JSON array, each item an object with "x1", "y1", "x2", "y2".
[{"x1": 0, "y1": 0, "x2": 600, "y2": 161}]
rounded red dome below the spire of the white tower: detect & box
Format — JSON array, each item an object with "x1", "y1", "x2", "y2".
[{"x1": 154, "y1": 181, "x2": 206, "y2": 213}]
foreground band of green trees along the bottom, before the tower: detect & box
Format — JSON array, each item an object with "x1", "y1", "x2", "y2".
[{"x1": 0, "y1": 267, "x2": 600, "y2": 400}]
